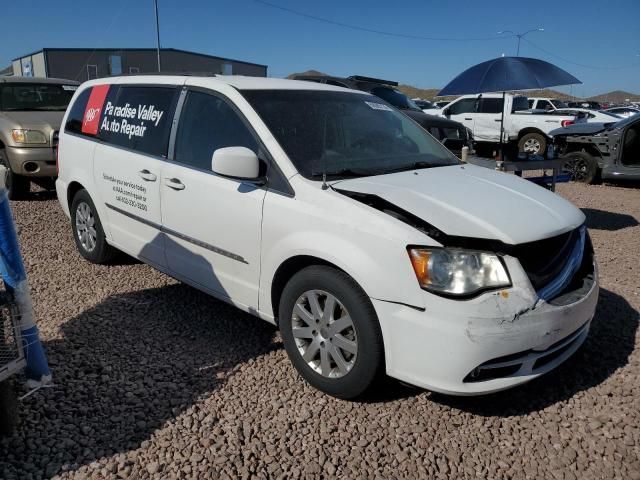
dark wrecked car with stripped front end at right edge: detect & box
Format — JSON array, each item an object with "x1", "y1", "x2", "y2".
[{"x1": 550, "y1": 115, "x2": 640, "y2": 183}]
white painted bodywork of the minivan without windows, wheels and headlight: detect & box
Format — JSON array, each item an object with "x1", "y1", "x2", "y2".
[{"x1": 56, "y1": 76, "x2": 598, "y2": 395}]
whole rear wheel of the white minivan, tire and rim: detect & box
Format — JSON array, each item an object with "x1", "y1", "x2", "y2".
[{"x1": 71, "y1": 190, "x2": 117, "y2": 263}]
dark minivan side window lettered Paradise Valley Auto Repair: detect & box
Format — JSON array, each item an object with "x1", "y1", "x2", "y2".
[{"x1": 99, "y1": 86, "x2": 178, "y2": 157}]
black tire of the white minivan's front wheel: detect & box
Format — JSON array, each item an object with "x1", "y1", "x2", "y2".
[{"x1": 278, "y1": 265, "x2": 384, "y2": 399}]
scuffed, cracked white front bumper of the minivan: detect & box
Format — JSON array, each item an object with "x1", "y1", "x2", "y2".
[{"x1": 372, "y1": 253, "x2": 599, "y2": 395}]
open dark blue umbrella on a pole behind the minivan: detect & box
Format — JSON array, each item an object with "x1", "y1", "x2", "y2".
[{"x1": 438, "y1": 57, "x2": 582, "y2": 158}]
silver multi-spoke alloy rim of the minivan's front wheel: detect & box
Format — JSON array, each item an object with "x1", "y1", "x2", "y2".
[{"x1": 291, "y1": 290, "x2": 358, "y2": 378}]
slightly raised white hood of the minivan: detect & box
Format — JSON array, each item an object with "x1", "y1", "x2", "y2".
[{"x1": 332, "y1": 165, "x2": 585, "y2": 245}]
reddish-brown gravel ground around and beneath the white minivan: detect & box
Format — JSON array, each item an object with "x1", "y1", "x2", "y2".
[{"x1": 0, "y1": 181, "x2": 640, "y2": 480}]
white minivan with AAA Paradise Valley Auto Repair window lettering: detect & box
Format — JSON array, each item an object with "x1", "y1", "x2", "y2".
[{"x1": 56, "y1": 76, "x2": 598, "y2": 398}]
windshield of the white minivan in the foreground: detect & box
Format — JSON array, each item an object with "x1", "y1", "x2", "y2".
[{"x1": 242, "y1": 90, "x2": 459, "y2": 179}]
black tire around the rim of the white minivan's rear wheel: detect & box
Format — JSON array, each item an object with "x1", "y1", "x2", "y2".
[{"x1": 71, "y1": 189, "x2": 117, "y2": 264}]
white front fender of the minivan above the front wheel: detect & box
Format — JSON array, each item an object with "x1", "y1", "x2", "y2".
[{"x1": 260, "y1": 176, "x2": 432, "y2": 315}]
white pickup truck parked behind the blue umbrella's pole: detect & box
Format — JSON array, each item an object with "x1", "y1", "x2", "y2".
[{"x1": 431, "y1": 93, "x2": 575, "y2": 155}]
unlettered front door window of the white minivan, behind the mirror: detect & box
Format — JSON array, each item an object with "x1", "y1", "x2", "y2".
[{"x1": 174, "y1": 91, "x2": 258, "y2": 170}]
